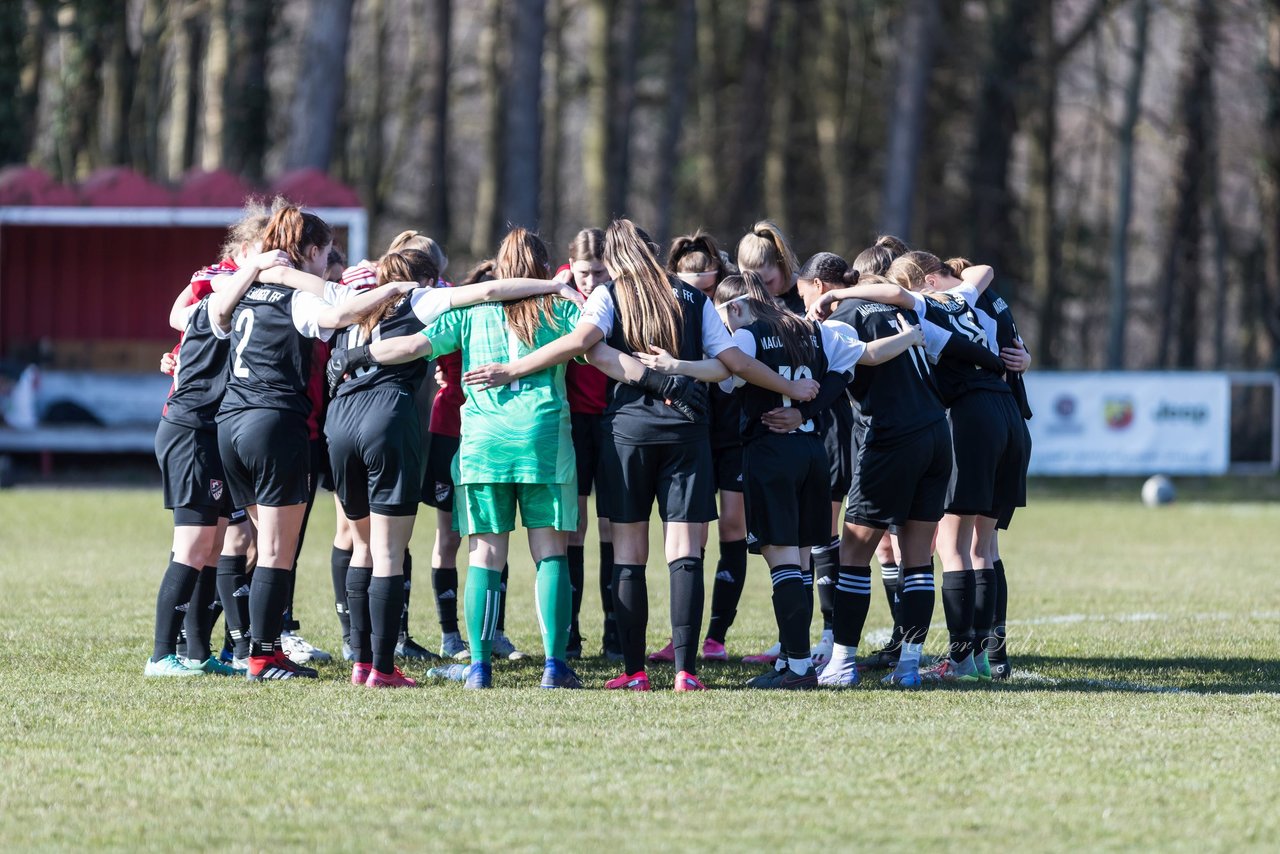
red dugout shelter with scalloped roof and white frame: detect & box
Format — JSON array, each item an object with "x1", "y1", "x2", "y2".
[{"x1": 0, "y1": 166, "x2": 369, "y2": 370}]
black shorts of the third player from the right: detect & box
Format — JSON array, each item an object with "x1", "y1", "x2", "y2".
[{"x1": 845, "y1": 419, "x2": 952, "y2": 528}]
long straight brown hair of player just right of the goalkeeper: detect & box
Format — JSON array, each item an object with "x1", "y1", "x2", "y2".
[{"x1": 604, "y1": 219, "x2": 681, "y2": 353}]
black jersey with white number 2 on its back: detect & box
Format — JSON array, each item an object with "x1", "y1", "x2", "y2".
[{"x1": 218, "y1": 284, "x2": 314, "y2": 419}]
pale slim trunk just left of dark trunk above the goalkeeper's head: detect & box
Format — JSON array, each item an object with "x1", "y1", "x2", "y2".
[{"x1": 471, "y1": 0, "x2": 506, "y2": 257}]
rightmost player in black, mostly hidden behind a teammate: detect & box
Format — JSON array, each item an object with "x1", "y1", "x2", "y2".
[{"x1": 962, "y1": 267, "x2": 1032, "y2": 680}]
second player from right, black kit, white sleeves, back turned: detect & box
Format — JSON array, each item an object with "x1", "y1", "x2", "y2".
[{"x1": 888, "y1": 252, "x2": 1027, "y2": 681}]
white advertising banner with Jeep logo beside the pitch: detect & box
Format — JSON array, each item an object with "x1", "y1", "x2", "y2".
[{"x1": 1027, "y1": 371, "x2": 1231, "y2": 475}]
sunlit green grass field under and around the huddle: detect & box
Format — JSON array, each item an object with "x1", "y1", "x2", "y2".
[{"x1": 0, "y1": 489, "x2": 1280, "y2": 851}]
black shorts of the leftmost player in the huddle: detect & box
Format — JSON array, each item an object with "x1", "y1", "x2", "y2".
[{"x1": 156, "y1": 421, "x2": 232, "y2": 528}]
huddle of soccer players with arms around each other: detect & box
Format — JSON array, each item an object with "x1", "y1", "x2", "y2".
[{"x1": 146, "y1": 202, "x2": 1030, "y2": 691}]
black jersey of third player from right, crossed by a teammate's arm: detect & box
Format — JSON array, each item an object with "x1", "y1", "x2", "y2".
[{"x1": 831, "y1": 300, "x2": 946, "y2": 444}]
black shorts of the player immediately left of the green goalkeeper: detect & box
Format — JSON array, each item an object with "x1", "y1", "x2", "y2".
[{"x1": 324, "y1": 385, "x2": 422, "y2": 519}]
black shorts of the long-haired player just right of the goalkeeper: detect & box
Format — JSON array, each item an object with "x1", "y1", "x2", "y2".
[{"x1": 596, "y1": 437, "x2": 716, "y2": 522}]
